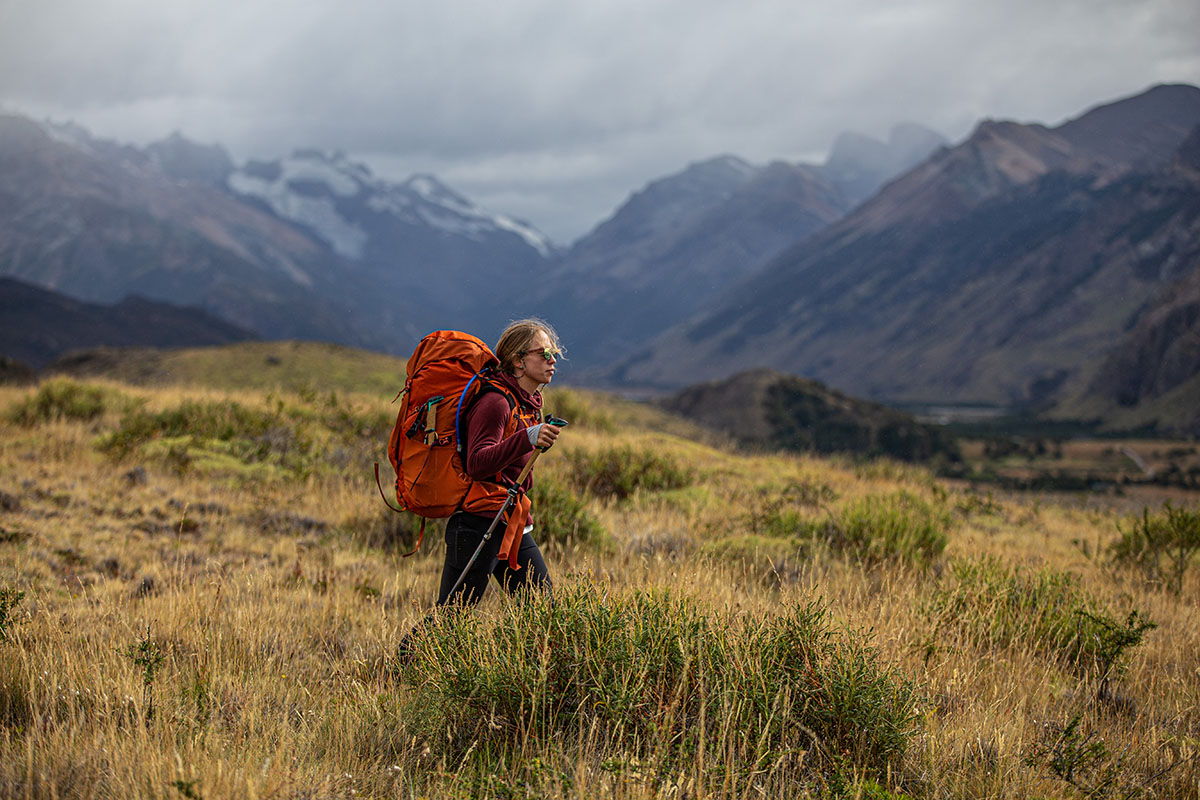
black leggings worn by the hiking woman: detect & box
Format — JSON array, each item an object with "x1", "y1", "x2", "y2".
[{"x1": 438, "y1": 511, "x2": 550, "y2": 606}]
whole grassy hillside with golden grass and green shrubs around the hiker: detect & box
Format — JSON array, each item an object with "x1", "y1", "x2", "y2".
[{"x1": 0, "y1": 367, "x2": 1200, "y2": 799}]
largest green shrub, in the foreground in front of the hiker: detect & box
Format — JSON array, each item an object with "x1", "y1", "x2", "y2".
[{"x1": 402, "y1": 584, "x2": 917, "y2": 776}]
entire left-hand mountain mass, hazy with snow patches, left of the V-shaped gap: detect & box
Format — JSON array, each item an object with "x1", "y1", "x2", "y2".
[{"x1": 0, "y1": 116, "x2": 554, "y2": 353}]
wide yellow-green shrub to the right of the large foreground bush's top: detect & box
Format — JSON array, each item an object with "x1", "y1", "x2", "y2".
[{"x1": 923, "y1": 559, "x2": 1153, "y2": 676}]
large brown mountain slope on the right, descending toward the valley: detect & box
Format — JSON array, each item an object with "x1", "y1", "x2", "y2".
[{"x1": 612, "y1": 86, "x2": 1200, "y2": 424}]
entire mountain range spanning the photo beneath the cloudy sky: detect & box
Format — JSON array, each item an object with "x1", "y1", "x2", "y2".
[{"x1": 0, "y1": 85, "x2": 1200, "y2": 429}]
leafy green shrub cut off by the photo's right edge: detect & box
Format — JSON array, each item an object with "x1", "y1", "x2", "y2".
[{"x1": 1110, "y1": 504, "x2": 1200, "y2": 594}]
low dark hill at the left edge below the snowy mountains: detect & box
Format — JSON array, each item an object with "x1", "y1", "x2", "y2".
[{"x1": 0, "y1": 272, "x2": 254, "y2": 367}]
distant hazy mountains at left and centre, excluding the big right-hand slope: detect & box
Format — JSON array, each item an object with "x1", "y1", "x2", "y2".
[{"x1": 0, "y1": 107, "x2": 943, "y2": 366}]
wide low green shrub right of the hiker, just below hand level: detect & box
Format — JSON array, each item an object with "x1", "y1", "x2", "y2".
[{"x1": 566, "y1": 445, "x2": 695, "y2": 500}]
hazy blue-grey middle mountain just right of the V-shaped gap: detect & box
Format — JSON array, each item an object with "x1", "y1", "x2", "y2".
[{"x1": 529, "y1": 157, "x2": 845, "y2": 362}]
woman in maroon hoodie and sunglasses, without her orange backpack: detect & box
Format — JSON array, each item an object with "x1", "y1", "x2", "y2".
[{"x1": 437, "y1": 319, "x2": 562, "y2": 607}]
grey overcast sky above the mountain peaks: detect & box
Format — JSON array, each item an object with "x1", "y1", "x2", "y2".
[{"x1": 0, "y1": 0, "x2": 1200, "y2": 242}]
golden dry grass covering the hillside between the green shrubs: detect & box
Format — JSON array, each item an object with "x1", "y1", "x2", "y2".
[{"x1": 0, "y1": 384, "x2": 1200, "y2": 799}]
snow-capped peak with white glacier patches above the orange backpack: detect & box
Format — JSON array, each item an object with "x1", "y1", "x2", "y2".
[{"x1": 226, "y1": 150, "x2": 557, "y2": 336}]
